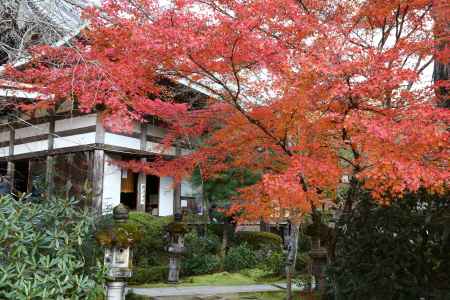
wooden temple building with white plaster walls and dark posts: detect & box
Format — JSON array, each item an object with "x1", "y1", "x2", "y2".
[{"x1": 0, "y1": 80, "x2": 203, "y2": 216}]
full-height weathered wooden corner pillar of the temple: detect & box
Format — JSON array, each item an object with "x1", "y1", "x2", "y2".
[{"x1": 92, "y1": 113, "x2": 105, "y2": 214}]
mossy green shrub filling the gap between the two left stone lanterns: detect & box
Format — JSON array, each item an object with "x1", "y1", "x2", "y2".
[{"x1": 128, "y1": 212, "x2": 173, "y2": 267}]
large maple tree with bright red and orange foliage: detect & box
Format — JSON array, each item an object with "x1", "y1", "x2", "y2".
[{"x1": 5, "y1": 0, "x2": 450, "y2": 294}]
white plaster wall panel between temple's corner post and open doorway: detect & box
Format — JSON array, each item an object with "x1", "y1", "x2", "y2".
[{"x1": 102, "y1": 154, "x2": 122, "y2": 213}]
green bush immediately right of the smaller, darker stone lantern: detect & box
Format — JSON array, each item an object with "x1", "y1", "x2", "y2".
[{"x1": 181, "y1": 231, "x2": 220, "y2": 275}]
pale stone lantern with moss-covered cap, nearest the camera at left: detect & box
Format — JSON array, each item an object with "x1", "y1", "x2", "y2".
[{"x1": 96, "y1": 204, "x2": 138, "y2": 300}]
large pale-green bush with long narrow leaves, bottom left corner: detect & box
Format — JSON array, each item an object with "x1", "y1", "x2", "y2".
[{"x1": 0, "y1": 196, "x2": 105, "y2": 299}]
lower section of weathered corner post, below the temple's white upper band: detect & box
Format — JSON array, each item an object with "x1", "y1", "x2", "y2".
[{"x1": 92, "y1": 150, "x2": 105, "y2": 214}]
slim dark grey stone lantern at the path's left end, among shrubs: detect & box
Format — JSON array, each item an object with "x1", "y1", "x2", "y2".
[{"x1": 167, "y1": 213, "x2": 188, "y2": 283}]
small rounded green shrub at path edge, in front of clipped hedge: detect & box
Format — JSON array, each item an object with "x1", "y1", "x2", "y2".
[{"x1": 223, "y1": 243, "x2": 258, "y2": 272}]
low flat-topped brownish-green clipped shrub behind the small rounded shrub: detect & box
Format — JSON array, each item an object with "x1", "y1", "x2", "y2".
[{"x1": 236, "y1": 231, "x2": 283, "y2": 251}]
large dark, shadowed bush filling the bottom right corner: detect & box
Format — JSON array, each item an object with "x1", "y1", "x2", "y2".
[{"x1": 329, "y1": 192, "x2": 450, "y2": 300}]
